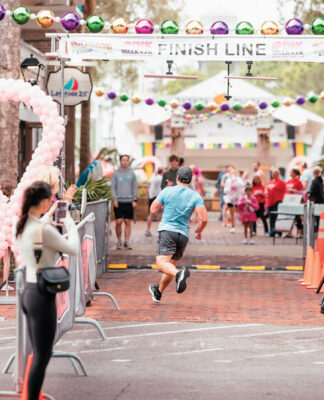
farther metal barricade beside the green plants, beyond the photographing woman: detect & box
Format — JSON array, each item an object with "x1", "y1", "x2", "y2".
[{"x1": 84, "y1": 199, "x2": 110, "y2": 278}]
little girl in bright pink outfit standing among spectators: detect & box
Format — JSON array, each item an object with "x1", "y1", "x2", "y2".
[{"x1": 237, "y1": 185, "x2": 259, "y2": 244}]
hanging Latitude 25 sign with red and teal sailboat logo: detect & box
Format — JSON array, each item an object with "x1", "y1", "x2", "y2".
[{"x1": 46, "y1": 67, "x2": 92, "y2": 106}]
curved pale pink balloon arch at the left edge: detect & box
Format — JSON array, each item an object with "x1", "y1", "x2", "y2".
[{"x1": 0, "y1": 79, "x2": 65, "y2": 263}]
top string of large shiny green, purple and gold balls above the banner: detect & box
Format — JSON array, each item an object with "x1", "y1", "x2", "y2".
[{"x1": 0, "y1": 4, "x2": 324, "y2": 35}]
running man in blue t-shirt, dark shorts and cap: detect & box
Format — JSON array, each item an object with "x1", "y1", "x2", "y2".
[{"x1": 149, "y1": 167, "x2": 207, "y2": 303}]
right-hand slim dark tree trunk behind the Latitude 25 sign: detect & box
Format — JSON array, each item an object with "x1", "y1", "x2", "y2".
[{"x1": 80, "y1": 0, "x2": 96, "y2": 173}]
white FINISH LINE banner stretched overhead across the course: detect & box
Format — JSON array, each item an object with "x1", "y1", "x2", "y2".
[{"x1": 56, "y1": 34, "x2": 324, "y2": 63}]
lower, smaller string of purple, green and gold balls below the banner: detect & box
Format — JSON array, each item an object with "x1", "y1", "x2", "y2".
[{"x1": 94, "y1": 88, "x2": 324, "y2": 112}]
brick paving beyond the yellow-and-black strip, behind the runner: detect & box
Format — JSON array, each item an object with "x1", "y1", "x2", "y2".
[{"x1": 109, "y1": 212, "x2": 303, "y2": 267}]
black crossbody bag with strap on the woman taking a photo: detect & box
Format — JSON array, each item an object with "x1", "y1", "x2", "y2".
[{"x1": 34, "y1": 225, "x2": 70, "y2": 294}]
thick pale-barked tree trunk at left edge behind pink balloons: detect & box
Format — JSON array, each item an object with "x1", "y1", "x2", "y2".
[{"x1": 0, "y1": 0, "x2": 20, "y2": 185}]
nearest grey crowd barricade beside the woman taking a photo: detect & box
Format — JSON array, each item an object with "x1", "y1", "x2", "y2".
[{"x1": 0, "y1": 213, "x2": 104, "y2": 398}]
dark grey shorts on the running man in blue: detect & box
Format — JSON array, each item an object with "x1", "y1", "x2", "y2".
[{"x1": 156, "y1": 231, "x2": 188, "y2": 260}]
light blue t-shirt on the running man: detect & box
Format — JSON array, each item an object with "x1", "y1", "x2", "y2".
[{"x1": 156, "y1": 185, "x2": 204, "y2": 236}]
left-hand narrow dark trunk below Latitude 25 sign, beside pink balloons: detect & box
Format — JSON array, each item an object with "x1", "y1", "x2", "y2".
[{"x1": 64, "y1": 107, "x2": 75, "y2": 184}]
